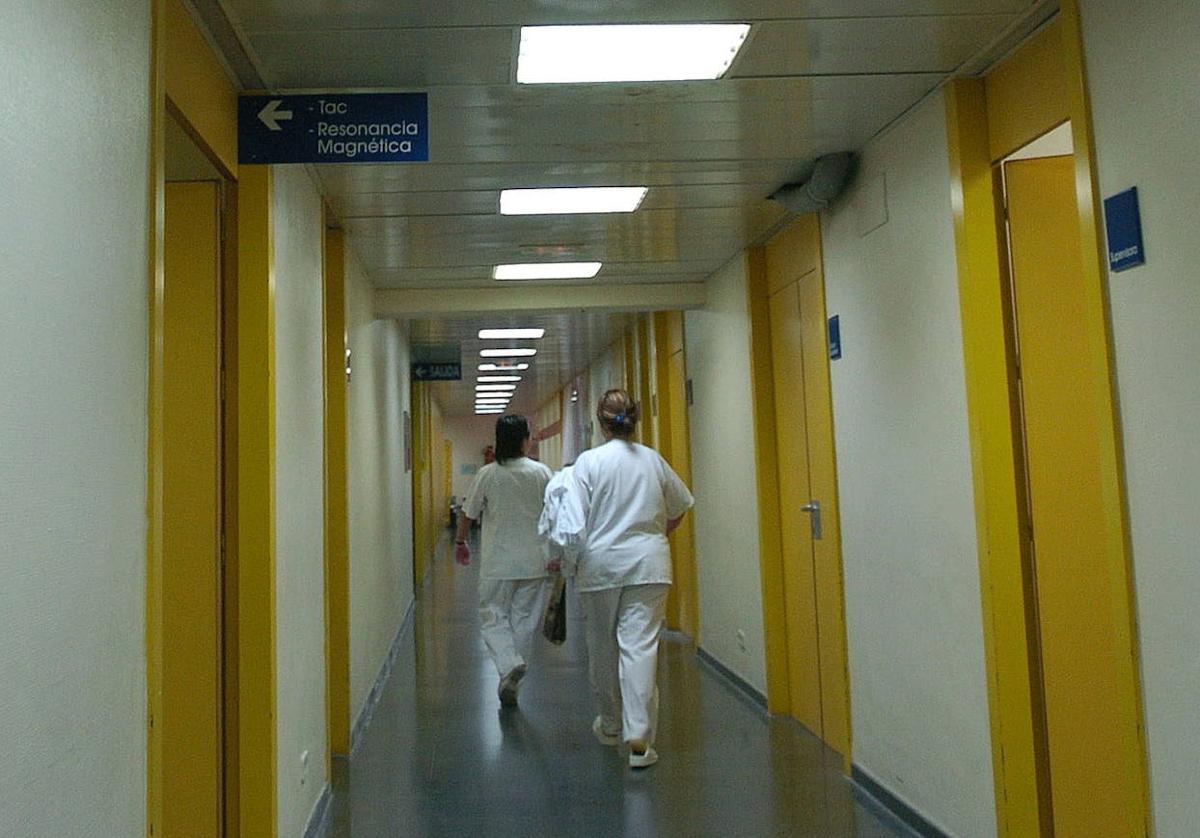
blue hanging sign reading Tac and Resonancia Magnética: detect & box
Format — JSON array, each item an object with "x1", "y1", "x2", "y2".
[{"x1": 238, "y1": 94, "x2": 430, "y2": 164}]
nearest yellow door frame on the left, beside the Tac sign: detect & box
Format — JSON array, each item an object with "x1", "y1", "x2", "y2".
[{"x1": 145, "y1": 0, "x2": 277, "y2": 837}]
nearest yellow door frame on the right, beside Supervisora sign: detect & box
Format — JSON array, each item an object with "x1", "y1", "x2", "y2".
[{"x1": 947, "y1": 9, "x2": 1152, "y2": 836}]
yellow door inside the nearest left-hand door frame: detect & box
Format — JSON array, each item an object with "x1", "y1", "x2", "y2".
[{"x1": 158, "y1": 181, "x2": 222, "y2": 837}]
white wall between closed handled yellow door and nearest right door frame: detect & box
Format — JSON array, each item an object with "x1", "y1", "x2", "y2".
[{"x1": 823, "y1": 88, "x2": 995, "y2": 838}]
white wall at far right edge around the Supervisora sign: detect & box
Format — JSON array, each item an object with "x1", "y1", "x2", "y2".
[{"x1": 1080, "y1": 0, "x2": 1200, "y2": 838}]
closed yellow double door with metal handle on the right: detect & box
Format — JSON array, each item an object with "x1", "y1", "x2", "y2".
[{"x1": 767, "y1": 216, "x2": 851, "y2": 759}]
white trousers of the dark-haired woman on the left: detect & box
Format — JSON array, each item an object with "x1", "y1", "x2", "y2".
[{"x1": 479, "y1": 577, "x2": 550, "y2": 678}]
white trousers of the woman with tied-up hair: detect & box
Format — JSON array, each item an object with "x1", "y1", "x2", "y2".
[{"x1": 580, "y1": 585, "x2": 671, "y2": 744}]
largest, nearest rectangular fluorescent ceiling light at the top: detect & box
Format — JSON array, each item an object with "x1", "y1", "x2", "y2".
[{"x1": 517, "y1": 23, "x2": 750, "y2": 84}]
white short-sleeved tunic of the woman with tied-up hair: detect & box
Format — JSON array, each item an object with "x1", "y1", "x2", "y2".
[{"x1": 571, "y1": 439, "x2": 694, "y2": 593}]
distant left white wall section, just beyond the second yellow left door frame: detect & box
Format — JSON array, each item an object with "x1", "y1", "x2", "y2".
[{"x1": 346, "y1": 256, "x2": 413, "y2": 720}]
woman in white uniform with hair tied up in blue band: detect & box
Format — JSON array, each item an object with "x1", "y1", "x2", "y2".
[{"x1": 571, "y1": 390, "x2": 692, "y2": 768}]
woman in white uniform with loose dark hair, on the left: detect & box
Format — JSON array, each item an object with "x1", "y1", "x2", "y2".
[{"x1": 455, "y1": 415, "x2": 552, "y2": 707}]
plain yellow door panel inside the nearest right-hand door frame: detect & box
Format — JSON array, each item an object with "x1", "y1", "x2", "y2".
[{"x1": 1004, "y1": 156, "x2": 1144, "y2": 838}]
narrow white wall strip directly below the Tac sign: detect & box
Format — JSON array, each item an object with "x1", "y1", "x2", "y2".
[{"x1": 272, "y1": 166, "x2": 328, "y2": 836}]
